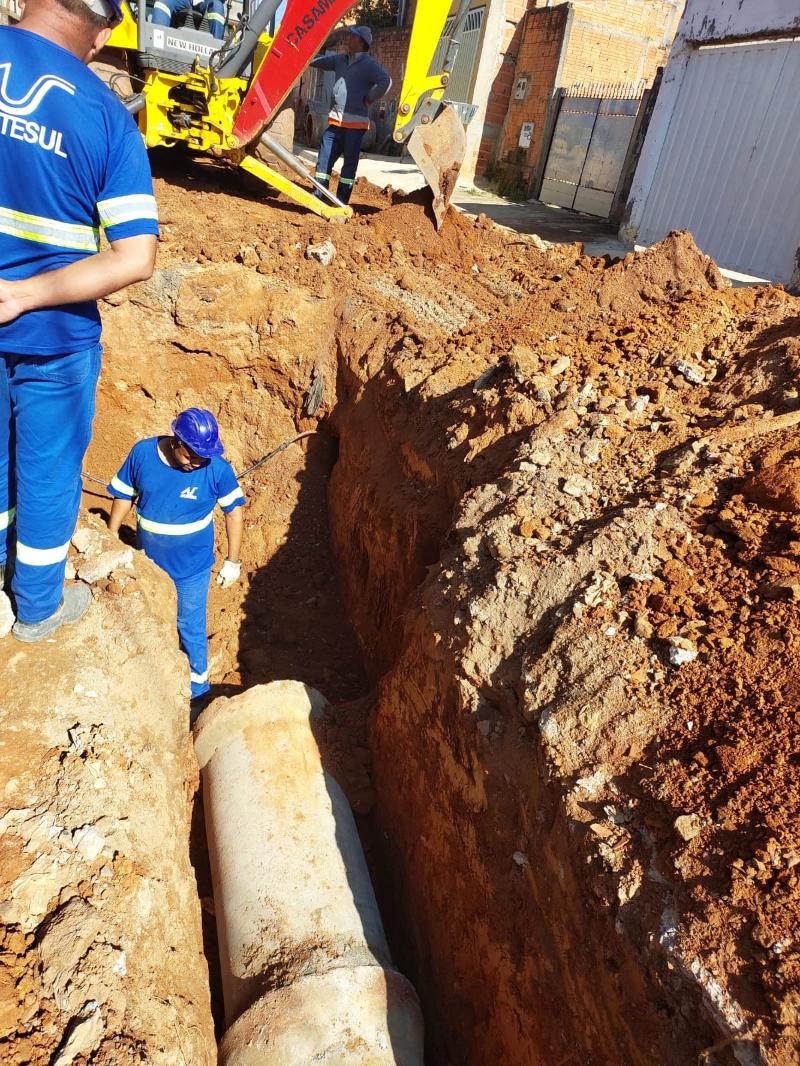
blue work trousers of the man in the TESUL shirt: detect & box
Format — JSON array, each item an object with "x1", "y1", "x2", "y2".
[{"x1": 0, "y1": 344, "x2": 102, "y2": 624}]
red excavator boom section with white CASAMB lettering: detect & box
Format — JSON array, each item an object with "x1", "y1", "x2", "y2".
[{"x1": 234, "y1": 0, "x2": 355, "y2": 145}]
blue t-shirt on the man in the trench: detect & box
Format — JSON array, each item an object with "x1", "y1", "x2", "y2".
[{"x1": 108, "y1": 437, "x2": 244, "y2": 581}]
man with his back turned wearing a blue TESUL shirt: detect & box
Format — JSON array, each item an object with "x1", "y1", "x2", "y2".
[{"x1": 0, "y1": 0, "x2": 158, "y2": 643}]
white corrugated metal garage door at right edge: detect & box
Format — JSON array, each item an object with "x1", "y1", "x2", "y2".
[{"x1": 638, "y1": 38, "x2": 800, "y2": 281}]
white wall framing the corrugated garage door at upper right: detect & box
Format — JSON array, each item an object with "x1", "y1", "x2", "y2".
[{"x1": 620, "y1": 0, "x2": 800, "y2": 280}]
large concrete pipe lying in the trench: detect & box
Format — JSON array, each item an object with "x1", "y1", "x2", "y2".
[{"x1": 195, "y1": 681, "x2": 422, "y2": 1066}]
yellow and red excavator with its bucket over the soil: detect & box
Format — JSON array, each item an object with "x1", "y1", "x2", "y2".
[{"x1": 102, "y1": 0, "x2": 469, "y2": 227}]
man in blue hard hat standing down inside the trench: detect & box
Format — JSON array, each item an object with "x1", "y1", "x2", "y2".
[{"x1": 109, "y1": 407, "x2": 244, "y2": 709}]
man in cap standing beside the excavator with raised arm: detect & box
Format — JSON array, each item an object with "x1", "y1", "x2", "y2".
[{"x1": 311, "y1": 26, "x2": 391, "y2": 204}]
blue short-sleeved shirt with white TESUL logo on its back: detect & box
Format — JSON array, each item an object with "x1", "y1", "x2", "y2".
[{"x1": 0, "y1": 26, "x2": 158, "y2": 356}]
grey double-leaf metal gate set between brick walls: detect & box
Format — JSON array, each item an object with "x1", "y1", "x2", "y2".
[{"x1": 539, "y1": 90, "x2": 641, "y2": 219}]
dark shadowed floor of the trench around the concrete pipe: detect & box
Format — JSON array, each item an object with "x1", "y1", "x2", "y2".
[{"x1": 190, "y1": 423, "x2": 413, "y2": 1044}]
